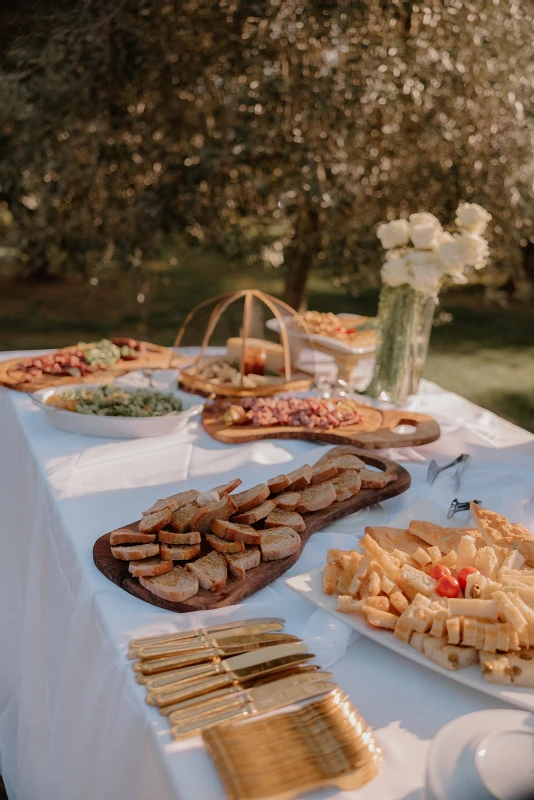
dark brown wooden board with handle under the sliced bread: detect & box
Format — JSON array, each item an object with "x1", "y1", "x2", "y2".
[{"x1": 93, "y1": 446, "x2": 411, "y2": 613}]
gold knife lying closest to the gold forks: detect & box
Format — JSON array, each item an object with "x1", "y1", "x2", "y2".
[{"x1": 170, "y1": 681, "x2": 337, "y2": 739}]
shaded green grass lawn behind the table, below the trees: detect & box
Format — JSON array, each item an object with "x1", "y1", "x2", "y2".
[{"x1": 0, "y1": 250, "x2": 534, "y2": 431}]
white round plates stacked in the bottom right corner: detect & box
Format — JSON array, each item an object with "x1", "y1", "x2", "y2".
[{"x1": 423, "y1": 709, "x2": 534, "y2": 800}]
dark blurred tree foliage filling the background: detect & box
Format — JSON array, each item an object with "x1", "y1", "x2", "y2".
[{"x1": 0, "y1": 0, "x2": 534, "y2": 432}]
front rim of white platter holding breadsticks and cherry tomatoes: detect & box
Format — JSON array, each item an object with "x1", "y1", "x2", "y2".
[{"x1": 285, "y1": 564, "x2": 534, "y2": 711}]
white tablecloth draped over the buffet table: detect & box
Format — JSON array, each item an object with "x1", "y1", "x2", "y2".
[{"x1": 0, "y1": 353, "x2": 534, "y2": 800}]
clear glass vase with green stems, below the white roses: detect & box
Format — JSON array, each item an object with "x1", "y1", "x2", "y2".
[{"x1": 365, "y1": 284, "x2": 438, "y2": 405}]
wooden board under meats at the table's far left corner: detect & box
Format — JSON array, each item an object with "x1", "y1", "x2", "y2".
[{"x1": 0, "y1": 342, "x2": 174, "y2": 392}]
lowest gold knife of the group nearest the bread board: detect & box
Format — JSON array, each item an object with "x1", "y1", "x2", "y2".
[{"x1": 133, "y1": 633, "x2": 299, "y2": 675}]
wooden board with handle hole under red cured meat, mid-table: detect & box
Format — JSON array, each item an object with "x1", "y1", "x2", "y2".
[{"x1": 202, "y1": 398, "x2": 440, "y2": 450}]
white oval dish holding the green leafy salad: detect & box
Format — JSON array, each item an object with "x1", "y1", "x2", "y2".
[{"x1": 30, "y1": 383, "x2": 202, "y2": 439}]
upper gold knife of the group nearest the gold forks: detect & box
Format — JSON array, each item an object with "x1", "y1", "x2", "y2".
[{"x1": 168, "y1": 667, "x2": 332, "y2": 723}]
